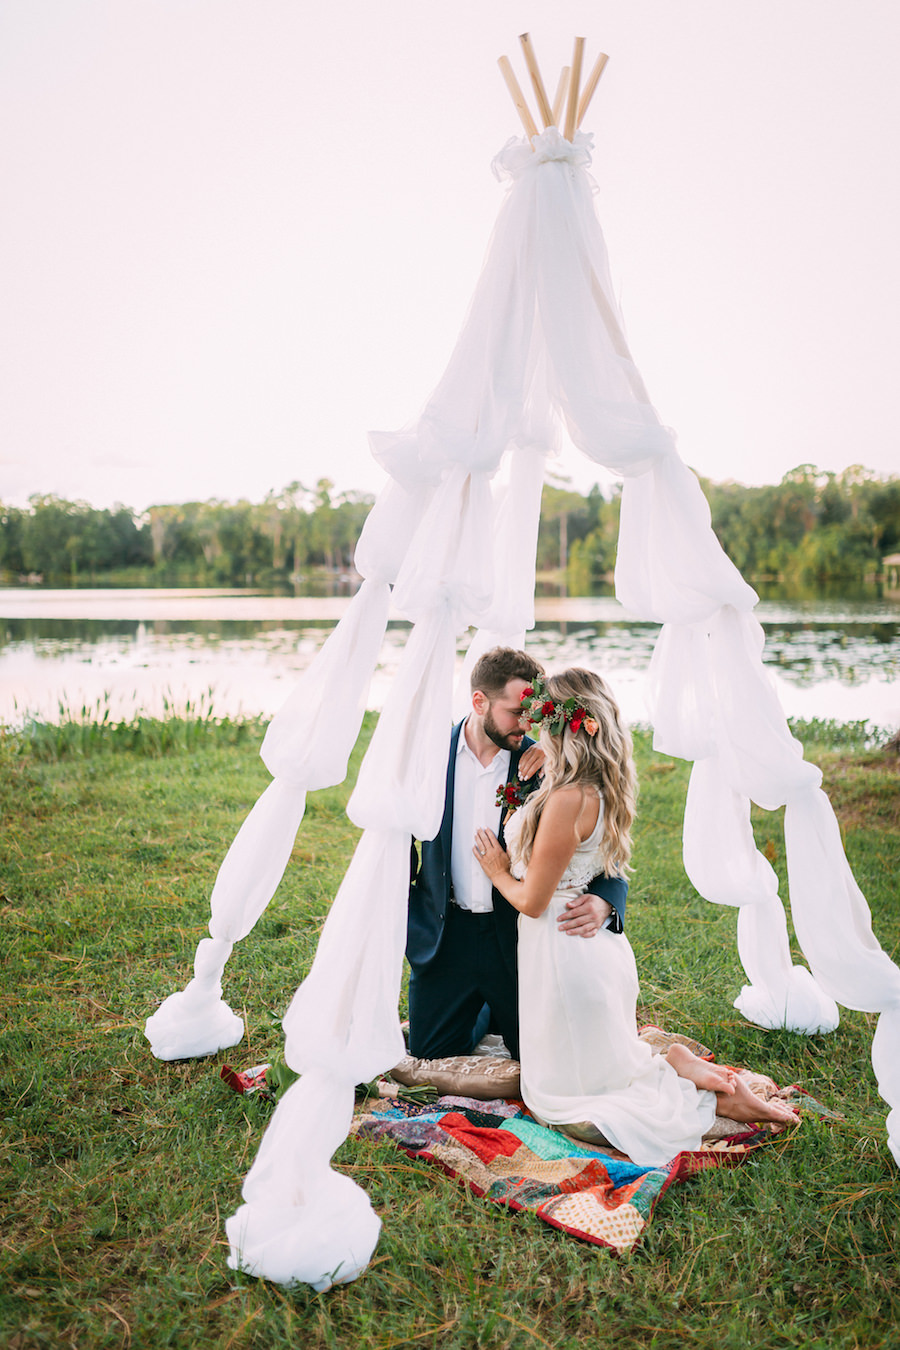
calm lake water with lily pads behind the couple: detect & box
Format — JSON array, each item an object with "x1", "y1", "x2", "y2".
[{"x1": 0, "y1": 589, "x2": 900, "y2": 728}]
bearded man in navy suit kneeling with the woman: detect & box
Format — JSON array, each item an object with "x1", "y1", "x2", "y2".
[{"x1": 406, "y1": 647, "x2": 627, "y2": 1060}]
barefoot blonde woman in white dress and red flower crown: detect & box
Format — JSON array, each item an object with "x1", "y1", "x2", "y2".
[{"x1": 475, "y1": 670, "x2": 797, "y2": 1165}]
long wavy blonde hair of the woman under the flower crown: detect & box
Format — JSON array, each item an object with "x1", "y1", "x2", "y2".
[{"x1": 515, "y1": 667, "x2": 637, "y2": 876}]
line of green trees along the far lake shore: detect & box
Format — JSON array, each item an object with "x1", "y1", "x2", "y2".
[{"x1": 0, "y1": 464, "x2": 900, "y2": 594}]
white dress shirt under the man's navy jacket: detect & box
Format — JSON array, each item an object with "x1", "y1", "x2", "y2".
[{"x1": 451, "y1": 725, "x2": 510, "y2": 914}]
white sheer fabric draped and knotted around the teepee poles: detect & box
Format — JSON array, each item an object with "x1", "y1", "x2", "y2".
[{"x1": 148, "y1": 128, "x2": 900, "y2": 1288}]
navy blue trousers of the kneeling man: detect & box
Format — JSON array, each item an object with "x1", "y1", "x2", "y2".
[{"x1": 409, "y1": 905, "x2": 518, "y2": 1060}]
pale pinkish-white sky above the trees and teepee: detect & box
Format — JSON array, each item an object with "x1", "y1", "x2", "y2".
[{"x1": 0, "y1": 0, "x2": 900, "y2": 509}]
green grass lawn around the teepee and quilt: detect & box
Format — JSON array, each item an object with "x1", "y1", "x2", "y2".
[{"x1": 0, "y1": 717, "x2": 900, "y2": 1350}]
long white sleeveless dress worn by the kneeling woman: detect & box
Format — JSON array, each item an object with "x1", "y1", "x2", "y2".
[{"x1": 506, "y1": 803, "x2": 715, "y2": 1165}]
